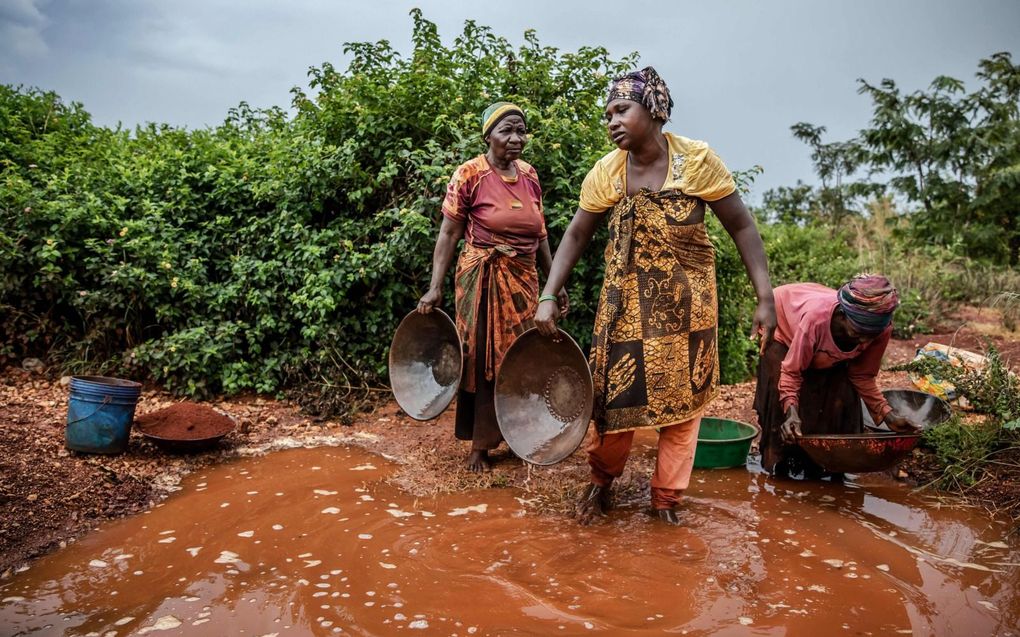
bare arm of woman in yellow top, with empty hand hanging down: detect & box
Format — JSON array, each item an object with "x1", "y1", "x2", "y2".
[{"x1": 709, "y1": 193, "x2": 776, "y2": 350}]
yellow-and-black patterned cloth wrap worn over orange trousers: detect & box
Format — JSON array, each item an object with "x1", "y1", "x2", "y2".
[{"x1": 590, "y1": 191, "x2": 719, "y2": 434}]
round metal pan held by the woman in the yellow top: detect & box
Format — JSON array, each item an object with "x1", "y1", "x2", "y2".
[{"x1": 495, "y1": 329, "x2": 595, "y2": 465}]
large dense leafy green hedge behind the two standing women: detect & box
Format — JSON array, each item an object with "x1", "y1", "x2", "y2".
[{"x1": 0, "y1": 11, "x2": 852, "y2": 411}]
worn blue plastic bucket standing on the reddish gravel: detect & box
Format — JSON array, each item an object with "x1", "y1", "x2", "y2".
[{"x1": 64, "y1": 376, "x2": 142, "y2": 454}]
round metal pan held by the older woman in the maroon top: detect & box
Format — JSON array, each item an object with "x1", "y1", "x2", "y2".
[{"x1": 390, "y1": 309, "x2": 464, "y2": 420}]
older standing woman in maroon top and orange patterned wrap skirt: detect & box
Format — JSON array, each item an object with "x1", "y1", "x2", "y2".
[{"x1": 418, "y1": 102, "x2": 567, "y2": 472}]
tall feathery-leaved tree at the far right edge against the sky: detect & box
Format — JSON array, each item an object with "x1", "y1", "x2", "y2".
[{"x1": 859, "y1": 52, "x2": 1020, "y2": 265}]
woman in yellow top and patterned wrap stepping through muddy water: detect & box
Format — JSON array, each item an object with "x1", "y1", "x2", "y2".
[{"x1": 534, "y1": 66, "x2": 776, "y2": 525}]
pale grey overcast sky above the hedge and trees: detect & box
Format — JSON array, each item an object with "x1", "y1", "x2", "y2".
[{"x1": 0, "y1": 0, "x2": 1020, "y2": 199}]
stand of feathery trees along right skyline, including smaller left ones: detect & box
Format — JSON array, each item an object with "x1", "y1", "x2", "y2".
[{"x1": 764, "y1": 52, "x2": 1020, "y2": 266}]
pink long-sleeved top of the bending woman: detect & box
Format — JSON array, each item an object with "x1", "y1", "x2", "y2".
[{"x1": 775, "y1": 283, "x2": 893, "y2": 423}]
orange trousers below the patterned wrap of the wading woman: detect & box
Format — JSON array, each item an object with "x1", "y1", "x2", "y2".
[{"x1": 587, "y1": 416, "x2": 701, "y2": 509}]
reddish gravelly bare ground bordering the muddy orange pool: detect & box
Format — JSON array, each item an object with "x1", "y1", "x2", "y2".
[{"x1": 0, "y1": 311, "x2": 1020, "y2": 577}]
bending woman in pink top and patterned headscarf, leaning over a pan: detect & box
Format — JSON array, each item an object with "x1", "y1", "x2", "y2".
[{"x1": 755, "y1": 276, "x2": 916, "y2": 478}]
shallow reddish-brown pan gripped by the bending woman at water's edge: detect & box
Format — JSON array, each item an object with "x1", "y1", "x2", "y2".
[{"x1": 797, "y1": 433, "x2": 921, "y2": 473}]
